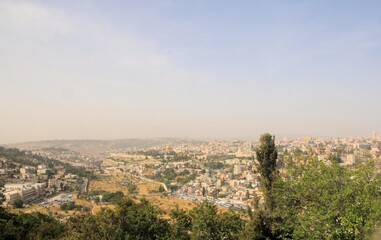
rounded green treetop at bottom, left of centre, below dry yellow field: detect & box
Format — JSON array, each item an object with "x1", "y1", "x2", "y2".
[{"x1": 64, "y1": 199, "x2": 169, "y2": 239}]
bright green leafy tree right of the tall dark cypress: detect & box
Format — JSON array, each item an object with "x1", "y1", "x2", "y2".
[{"x1": 273, "y1": 159, "x2": 381, "y2": 239}]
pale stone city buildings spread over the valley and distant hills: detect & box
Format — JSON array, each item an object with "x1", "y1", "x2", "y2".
[{"x1": 0, "y1": 132, "x2": 381, "y2": 208}]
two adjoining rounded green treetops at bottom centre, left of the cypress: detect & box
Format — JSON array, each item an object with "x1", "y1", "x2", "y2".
[{"x1": 63, "y1": 199, "x2": 244, "y2": 240}]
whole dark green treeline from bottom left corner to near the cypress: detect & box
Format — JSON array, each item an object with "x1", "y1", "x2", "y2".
[{"x1": 0, "y1": 198, "x2": 244, "y2": 240}]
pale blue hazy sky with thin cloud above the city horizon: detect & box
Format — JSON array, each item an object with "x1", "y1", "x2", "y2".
[{"x1": 0, "y1": 0, "x2": 381, "y2": 143}]
